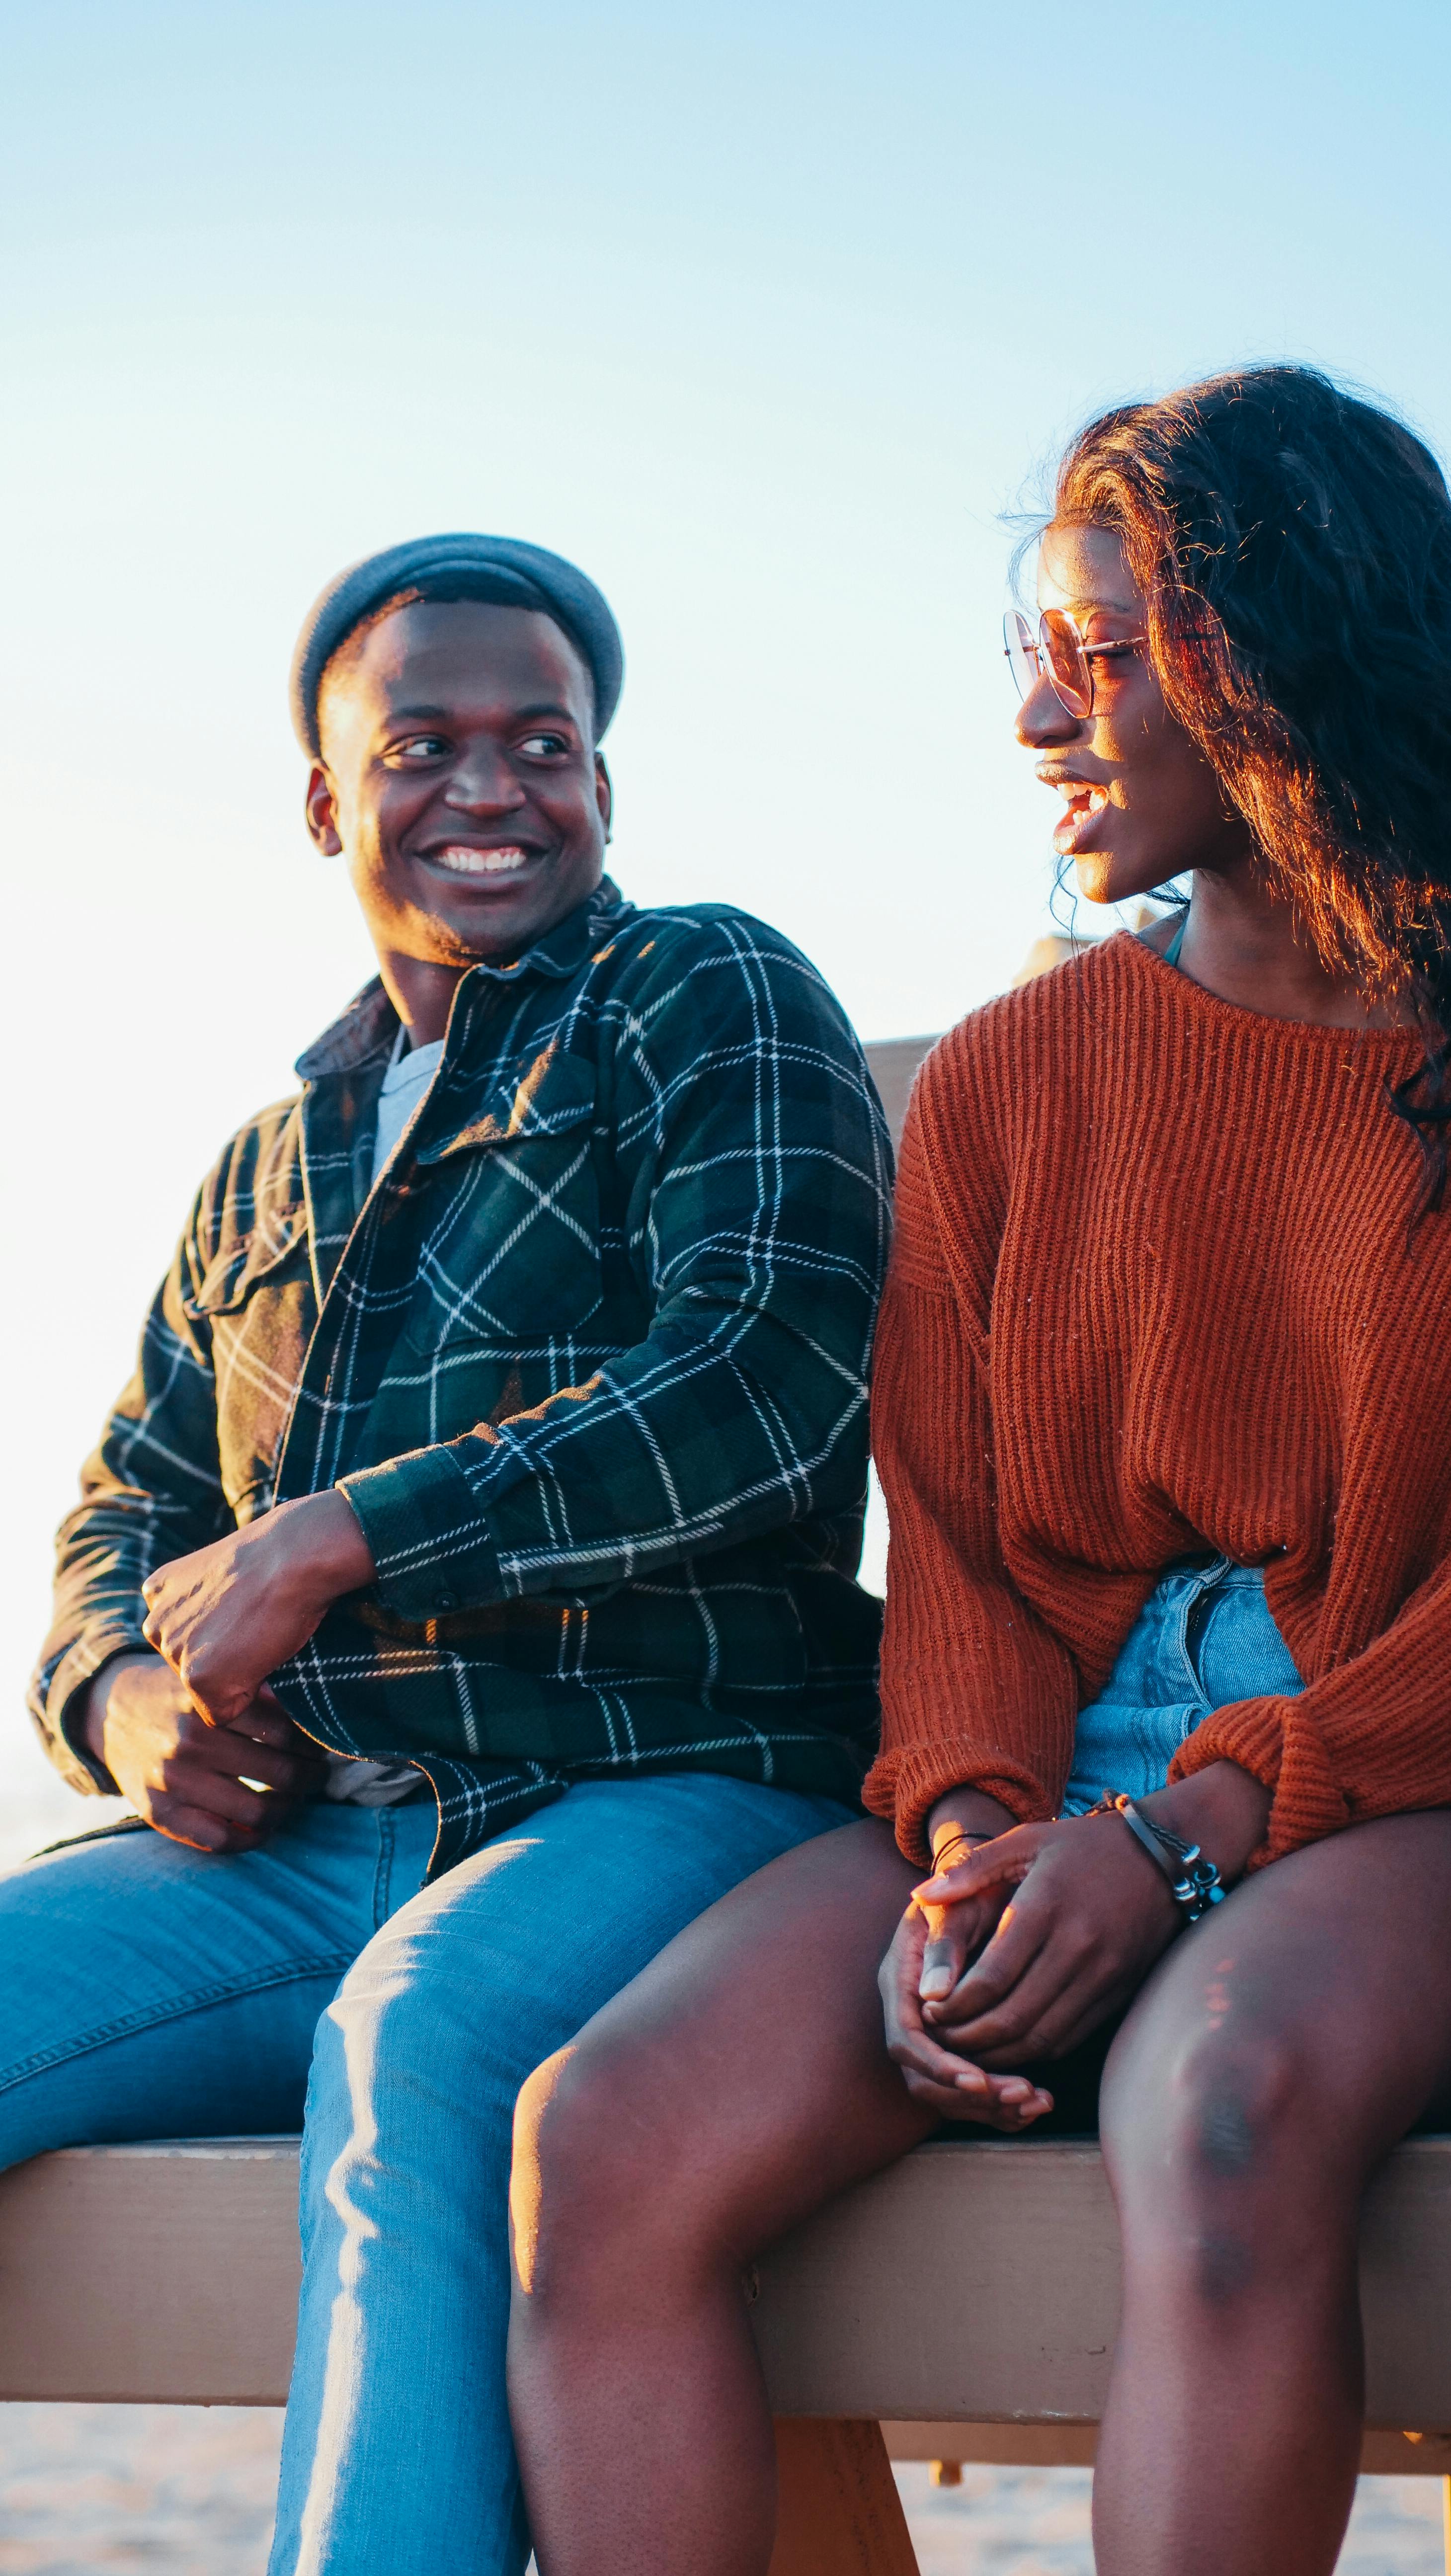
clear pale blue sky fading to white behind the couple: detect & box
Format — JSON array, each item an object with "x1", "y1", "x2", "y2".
[{"x1": 0, "y1": 0, "x2": 1451, "y2": 1850}]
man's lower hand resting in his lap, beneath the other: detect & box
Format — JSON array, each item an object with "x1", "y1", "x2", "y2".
[{"x1": 82, "y1": 1654, "x2": 322, "y2": 1852}]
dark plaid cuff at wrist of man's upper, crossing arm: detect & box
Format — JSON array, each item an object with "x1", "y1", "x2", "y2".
[{"x1": 337, "y1": 1448, "x2": 505, "y2": 1620}]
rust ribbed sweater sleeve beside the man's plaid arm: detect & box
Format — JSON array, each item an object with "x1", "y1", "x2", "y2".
[{"x1": 863, "y1": 1031, "x2": 1080, "y2": 1865}]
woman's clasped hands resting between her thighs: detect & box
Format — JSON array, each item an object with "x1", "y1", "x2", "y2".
[{"x1": 882, "y1": 1816, "x2": 1178, "y2": 2133}]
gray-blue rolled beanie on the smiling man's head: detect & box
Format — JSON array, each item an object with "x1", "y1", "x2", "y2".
[{"x1": 291, "y1": 533, "x2": 624, "y2": 760}]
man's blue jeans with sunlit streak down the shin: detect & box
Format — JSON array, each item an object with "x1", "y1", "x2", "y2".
[{"x1": 0, "y1": 1772, "x2": 851, "y2": 2576}]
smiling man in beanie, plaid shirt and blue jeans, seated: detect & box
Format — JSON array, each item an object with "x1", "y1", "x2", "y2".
[{"x1": 11, "y1": 536, "x2": 889, "y2": 2576}]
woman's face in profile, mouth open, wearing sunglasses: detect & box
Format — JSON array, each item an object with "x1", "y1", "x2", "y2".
[{"x1": 1018, "y1": 523, "x2": 1253, "y2": 904}]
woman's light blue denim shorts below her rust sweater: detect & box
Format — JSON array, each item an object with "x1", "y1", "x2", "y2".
[{"x1": 1062, "y1": 1556, "x2": 1304, "y2": 1816}]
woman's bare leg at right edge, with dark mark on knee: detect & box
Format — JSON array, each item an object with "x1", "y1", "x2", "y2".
[{"x1": 1093, "y1": 1811, "x2": 1451, "y2": 2576}]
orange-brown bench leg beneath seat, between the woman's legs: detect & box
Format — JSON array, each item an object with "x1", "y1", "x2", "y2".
[{"x1": 771, "y1": 2416, "x2": 917, "y2": 2576}]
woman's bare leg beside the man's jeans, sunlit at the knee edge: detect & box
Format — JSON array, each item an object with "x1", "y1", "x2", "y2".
[{"x1": 510, "y1": 1824, "x2": 933, "y2": 2576}]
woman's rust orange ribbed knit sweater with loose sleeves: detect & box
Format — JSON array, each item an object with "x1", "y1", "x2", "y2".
[{"x1": 866, "y1": 935, "x2": 1451, "y2": 1860}]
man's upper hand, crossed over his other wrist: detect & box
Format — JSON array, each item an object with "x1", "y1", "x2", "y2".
[{"x1": 142, "y1": 1486, "x2": 374, "y2": 1726}]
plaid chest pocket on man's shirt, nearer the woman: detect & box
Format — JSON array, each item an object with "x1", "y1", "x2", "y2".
[{"x1": 404, "y1": 1053, "x2": 603, "y2": 1360}]
